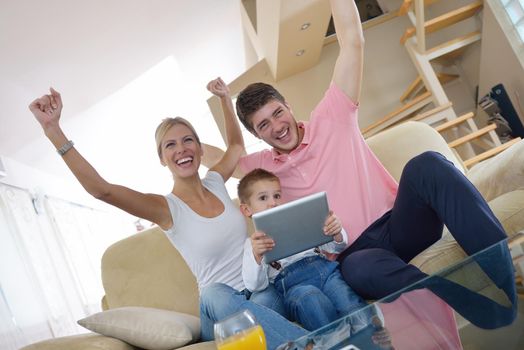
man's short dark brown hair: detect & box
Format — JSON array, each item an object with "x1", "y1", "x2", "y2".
[{"x1": 236, "y1": 83, "x2": 286, "y2": 134}]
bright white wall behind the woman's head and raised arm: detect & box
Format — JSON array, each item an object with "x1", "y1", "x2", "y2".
[{"x1": 0, "y1": 52, "x2": 247, "y2": 212}]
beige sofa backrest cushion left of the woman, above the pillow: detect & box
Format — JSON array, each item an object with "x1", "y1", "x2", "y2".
[{"x1": 102, "y1": 227, "x2": 199, "y2": 316}]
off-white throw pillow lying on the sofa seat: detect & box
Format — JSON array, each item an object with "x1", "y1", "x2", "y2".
[{"x1": 78, "y1": 306, "x2": 200, "y2": 350}]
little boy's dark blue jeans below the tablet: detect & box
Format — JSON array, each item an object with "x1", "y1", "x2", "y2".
[{"x1": 274, "y1": 255, "x2": 367, "y2": 331}]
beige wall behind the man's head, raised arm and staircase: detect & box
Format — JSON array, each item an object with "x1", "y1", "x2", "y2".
[{"x1": 221, "y1": 8, "x2": 478, "y2": 128}]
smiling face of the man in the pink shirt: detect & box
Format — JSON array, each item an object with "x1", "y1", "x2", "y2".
[{"x1": 250, "y1": 99, "x2": 303, "y2": 153}]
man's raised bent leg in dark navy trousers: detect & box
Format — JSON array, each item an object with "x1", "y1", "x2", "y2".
[{"x1": 387, "y1": 152, "x2": 506, "y2": 262}]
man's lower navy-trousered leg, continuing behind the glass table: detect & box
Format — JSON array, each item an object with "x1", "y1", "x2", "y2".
[{"x1": 342, "y1": 245, "x2": 517, "y2": 329}]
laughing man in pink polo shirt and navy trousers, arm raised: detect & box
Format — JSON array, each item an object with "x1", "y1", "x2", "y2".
[{"x1": 208, "y1": 0, "x2": 516, "y2": 328}]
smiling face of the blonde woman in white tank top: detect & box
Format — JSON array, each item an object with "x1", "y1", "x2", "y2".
[{"x1": 159, "y1": 124, "x2": 202, "y2": 178}]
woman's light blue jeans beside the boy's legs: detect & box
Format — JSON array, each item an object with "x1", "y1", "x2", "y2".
[{"x1": 200, "y1": 283, "x2": 307, "y2": 350}]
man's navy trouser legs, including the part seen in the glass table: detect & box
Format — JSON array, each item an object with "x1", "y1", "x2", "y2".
[{"x1": 342, "y1": 152, "x2": 516, "y2": 328}]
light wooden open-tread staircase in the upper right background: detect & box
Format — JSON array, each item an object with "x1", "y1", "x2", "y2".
[{"x1": 362, "y1": 0, "x2": 518, "y2": 167}]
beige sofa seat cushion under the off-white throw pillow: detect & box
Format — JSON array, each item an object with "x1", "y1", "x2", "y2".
[{"x1": 20, "y1": 333, "x2": 136, "y2": 350}]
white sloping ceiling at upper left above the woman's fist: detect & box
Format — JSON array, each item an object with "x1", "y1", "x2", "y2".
[{"x1": 0, "y1": 0, "x2": 245, "y2": 168}]
